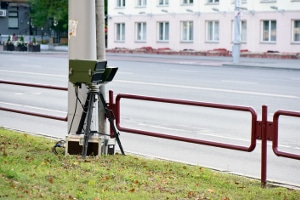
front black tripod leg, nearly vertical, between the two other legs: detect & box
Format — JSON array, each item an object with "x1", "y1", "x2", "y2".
[{"x1": 82, "y1": 93, "x2": 95, "y2": 159}]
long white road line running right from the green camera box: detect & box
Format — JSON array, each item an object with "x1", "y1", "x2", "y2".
[{"x1": 115, "y1": 80, "x2": 300, "y2": 99}]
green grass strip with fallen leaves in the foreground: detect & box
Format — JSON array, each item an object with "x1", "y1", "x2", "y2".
[{"x1": 0, "y1": 128, "x2": 300, "y2": 200}]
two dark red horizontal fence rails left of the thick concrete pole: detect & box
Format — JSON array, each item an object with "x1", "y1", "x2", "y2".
[{"x1": 0, "y1": 80, "x2": 68, "y2": 121}]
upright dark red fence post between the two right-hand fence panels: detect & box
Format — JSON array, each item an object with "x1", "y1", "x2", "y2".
[{"x1": 261, "y1": 105, "x2": 268, "y2": 188}]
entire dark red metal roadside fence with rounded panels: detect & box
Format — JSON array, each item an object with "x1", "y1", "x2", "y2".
[{"x1": 0, "y1": 80, "x2": 300, "y2": 187}]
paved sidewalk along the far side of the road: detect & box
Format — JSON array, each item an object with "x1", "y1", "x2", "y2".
[{"x1": 0, "y1": 45, "x2": 300, "y2": 70}]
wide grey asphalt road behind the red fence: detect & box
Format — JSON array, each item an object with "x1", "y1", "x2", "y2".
[{"x1": 0, "y1": 53, "x2": 300, "y2": 186}]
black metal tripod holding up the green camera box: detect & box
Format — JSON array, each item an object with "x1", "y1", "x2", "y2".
[{"x1": 76, "y1": 88, "x2": 125, "y2": 159}]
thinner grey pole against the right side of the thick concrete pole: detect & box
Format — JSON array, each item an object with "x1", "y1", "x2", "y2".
[{"x1": 96, "y1": 0, "x2": 107, "y2": 136}]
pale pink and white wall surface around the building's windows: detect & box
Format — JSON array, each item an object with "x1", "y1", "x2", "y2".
[{"x1": 108, "y1": 0, "x2": 300, "y2": 53}]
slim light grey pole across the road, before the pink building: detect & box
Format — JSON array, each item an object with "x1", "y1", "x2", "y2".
[{"x1": 232, "y1": 0, "x2": 241, "y2": 64}]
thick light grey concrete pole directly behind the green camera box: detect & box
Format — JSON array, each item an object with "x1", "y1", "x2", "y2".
[{"x1": 68, "y1": 0, "x2": 96, "y2": 134}]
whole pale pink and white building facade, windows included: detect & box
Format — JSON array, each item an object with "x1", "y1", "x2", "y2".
[{"x1": 107, "y1": 0, "x2": 300, "y2": 53}]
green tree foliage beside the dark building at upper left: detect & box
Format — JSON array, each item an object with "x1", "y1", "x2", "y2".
[{"x1": 29, "y1": 0, "x2": 68, "y2": 31}]
